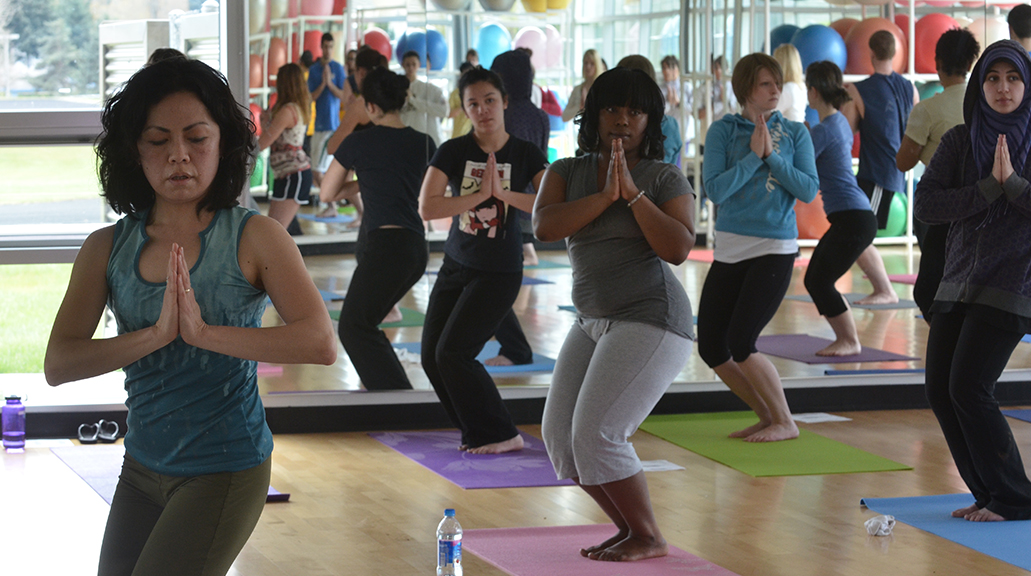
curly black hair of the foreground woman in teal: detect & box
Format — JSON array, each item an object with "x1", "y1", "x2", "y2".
[{"x1": 95, "y1": 58, "x2": 255, "y2": 215}]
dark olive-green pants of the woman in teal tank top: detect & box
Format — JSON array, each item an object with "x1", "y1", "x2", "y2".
[{"x1": 98, "y1": 454, "x2": 272, "y2": 576}]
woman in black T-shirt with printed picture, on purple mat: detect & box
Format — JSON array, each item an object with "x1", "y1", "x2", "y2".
[{"x1": 419, "y1": 68, "x2": 547, "y2": 453}]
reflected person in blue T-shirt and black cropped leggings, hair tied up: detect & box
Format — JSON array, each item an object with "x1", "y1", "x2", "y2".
[{"x1": 805, "y1": 61, "x2": 877, "y2": 355}]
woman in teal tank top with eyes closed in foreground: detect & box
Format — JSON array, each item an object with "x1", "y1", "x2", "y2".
[{"x1": 44, "y1": 58, "x2": 337, "y2": 576}]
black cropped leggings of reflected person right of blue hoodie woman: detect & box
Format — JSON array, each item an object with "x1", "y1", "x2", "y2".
[{"x1": 804, "y1": 210, "x2": 877, "y2": 318}]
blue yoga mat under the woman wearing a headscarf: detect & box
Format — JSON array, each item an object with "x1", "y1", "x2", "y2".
[{"x1": 860, "y1": 494, "x2": 1031, "y2": 570}]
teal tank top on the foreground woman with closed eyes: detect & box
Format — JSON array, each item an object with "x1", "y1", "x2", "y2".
[{"x1": 107, "y1": 207, "x2": 272, "y2": 476}]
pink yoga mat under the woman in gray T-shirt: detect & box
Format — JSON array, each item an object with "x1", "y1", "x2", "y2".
[{"x1": 462, "y1": 524, "x2": 737, "y2": 576}]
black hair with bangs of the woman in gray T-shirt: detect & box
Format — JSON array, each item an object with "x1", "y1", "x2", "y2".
[{"x1": 575, "y1": 66, "x2": 666, "y2": 160}]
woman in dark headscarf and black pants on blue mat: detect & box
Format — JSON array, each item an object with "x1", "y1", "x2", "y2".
[{"x1": 914, "y1": 40, "x2": 1031, "y2": 521}]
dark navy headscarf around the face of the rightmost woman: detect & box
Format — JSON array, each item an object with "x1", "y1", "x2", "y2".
[{"x1": 963, "y1": 40, "x2": 1031, "y2": 178}]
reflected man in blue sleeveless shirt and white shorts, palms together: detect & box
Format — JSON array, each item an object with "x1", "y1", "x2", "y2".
[{"x1": 308, "y1": 32, "x2": 347, "y2": 185}]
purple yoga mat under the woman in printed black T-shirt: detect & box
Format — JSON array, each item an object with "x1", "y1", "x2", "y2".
[{"x1": 369, "y1": 430, "x2": 572, "y2": 489}]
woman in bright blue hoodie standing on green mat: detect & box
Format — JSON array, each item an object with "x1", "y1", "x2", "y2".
[{"x1": 698, "y1": 54, "x2": 819, "y2": 442}]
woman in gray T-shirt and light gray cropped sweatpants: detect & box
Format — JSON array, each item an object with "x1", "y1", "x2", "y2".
[{"x1": 533, "y1": 67, "x2": 695, "y2": 562}]
